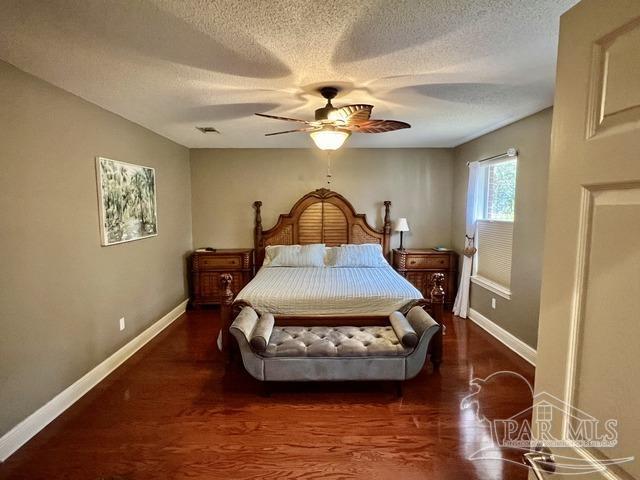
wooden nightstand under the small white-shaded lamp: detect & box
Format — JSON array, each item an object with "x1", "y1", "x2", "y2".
[{"x1": 393, "y1": 248, "x2": 458, "y2": 308}]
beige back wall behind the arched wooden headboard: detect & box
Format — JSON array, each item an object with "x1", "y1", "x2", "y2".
[{"x1": 191, "y1": 148, "x2": 453, "y2": 248}]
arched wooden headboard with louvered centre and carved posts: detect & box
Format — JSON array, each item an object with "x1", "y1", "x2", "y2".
[{"x1": 253, "y1": 188, "x2": 391, "y2": 268}]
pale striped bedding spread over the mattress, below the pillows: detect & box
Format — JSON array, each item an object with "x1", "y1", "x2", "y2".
[{"x1": 236, "y1": 266, "x2": 422, "y2": 315}]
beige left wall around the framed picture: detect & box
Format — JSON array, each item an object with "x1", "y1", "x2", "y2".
[{"x1": 0, "y1": 62, "x2": 192, "y2": 436}]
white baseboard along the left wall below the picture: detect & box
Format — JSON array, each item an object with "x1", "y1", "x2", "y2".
[{"x1": 0, "y1": 300, "x2": 188, "y2": 462}]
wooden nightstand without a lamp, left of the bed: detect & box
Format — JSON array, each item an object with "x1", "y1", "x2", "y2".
[{"x1": 189, "y1": 248, "x2": 253, "y2": 307}]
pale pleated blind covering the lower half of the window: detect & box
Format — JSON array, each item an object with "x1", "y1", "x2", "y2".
[{"x1": 476, "y1": 220, "x2": 513, "y2": 289}]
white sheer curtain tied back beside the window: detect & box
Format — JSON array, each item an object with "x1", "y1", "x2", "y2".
[{"x1": 453, "y1": 162, "x2": 480, "y2": 318}]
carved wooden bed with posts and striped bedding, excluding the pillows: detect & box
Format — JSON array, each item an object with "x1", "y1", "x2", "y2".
[{"x1": 220, "y1": 188, "x2": 444, "y2": 367}]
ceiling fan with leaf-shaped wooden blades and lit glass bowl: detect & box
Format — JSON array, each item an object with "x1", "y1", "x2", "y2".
[{"x1": 256, "y1": 87, "x2": 411, "y2": 150}]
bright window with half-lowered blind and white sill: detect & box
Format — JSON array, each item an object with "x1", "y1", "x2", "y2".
[{"x1": 471, "y1": 159, "x2": 517, "y2": 298}]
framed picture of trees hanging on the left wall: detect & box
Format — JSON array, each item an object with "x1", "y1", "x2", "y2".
[{"x1": 96, "y1": 157, "x2": 158, "y2": 246}]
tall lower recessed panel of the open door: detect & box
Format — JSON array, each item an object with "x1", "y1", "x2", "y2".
[{"x1": 572, "y1": 185, "x2": 640, "y2": 478}]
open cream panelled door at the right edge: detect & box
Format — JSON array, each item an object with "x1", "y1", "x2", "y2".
[{"x1": 532, "y1": 0, "x2": 640, "y2": 480}]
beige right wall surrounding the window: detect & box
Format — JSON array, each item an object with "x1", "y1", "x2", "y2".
[{"x1": 452, "y1": 108, "x2": 552, "y2": 348}]
